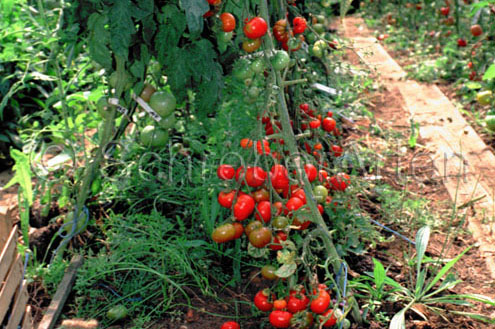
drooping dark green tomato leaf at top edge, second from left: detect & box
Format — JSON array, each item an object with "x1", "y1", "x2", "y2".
[{"x1": 108, "y1": 0, "x2": 136, "y2": 60}]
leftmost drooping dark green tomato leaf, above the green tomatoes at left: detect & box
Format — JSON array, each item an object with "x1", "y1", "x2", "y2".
[{"x1": 88, "y1": 13, "x2": 112, "y2": 71}]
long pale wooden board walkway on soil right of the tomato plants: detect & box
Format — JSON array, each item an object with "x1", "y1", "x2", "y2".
[{"x1": 343, "y1": 18, "x2": 495, "y2": 278}]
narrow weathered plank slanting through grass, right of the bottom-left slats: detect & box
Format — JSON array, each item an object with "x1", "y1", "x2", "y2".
[{"x1": 37, "y1": 255, "x2": 83, "y2": 329}]
